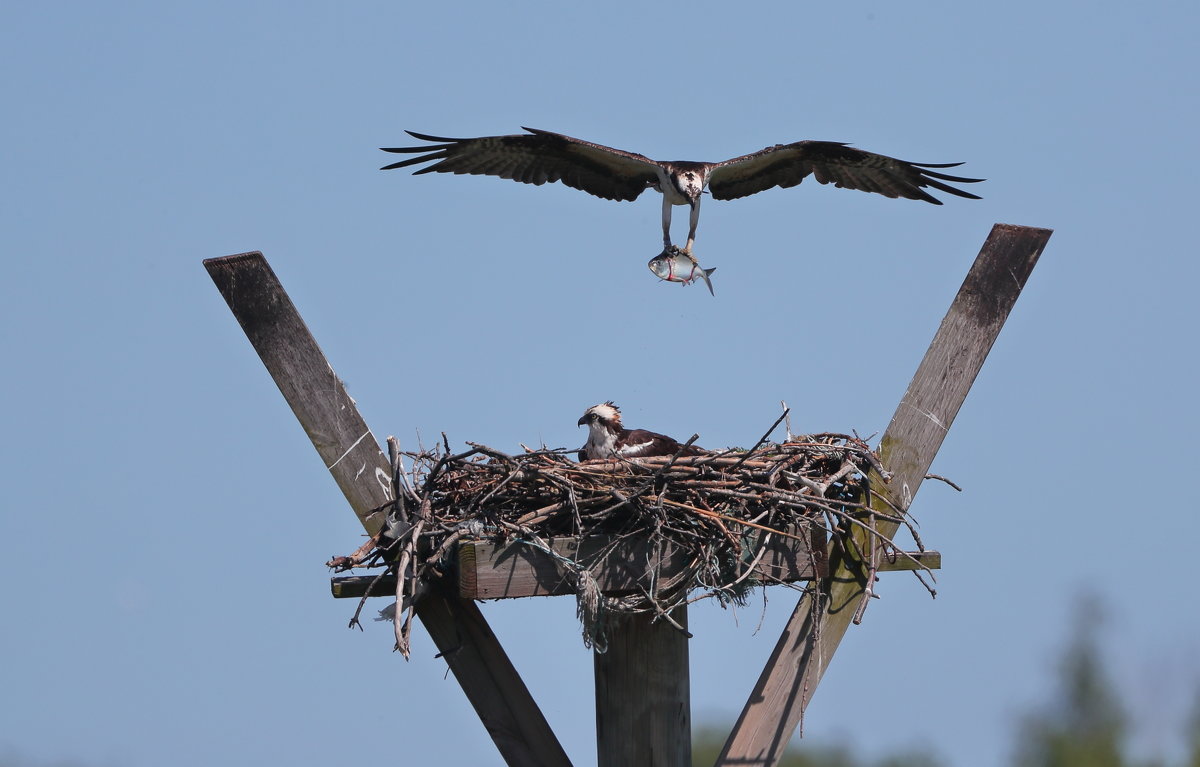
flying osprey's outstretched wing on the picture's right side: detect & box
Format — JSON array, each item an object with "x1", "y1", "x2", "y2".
[{"x1": 708, "y1": 142, "x2": 983, "y2": 205}]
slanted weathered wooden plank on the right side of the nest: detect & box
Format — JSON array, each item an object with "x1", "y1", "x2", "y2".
[{"x1": 716, "y1": 224, "x2": 1051, "y2": 767}]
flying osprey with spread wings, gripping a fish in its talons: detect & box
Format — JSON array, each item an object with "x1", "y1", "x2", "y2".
[{"x1": 380, "y1": 128, "x2": 983, "y2": 256}]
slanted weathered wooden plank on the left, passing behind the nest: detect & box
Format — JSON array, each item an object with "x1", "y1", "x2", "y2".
[{"x1": 204, "y1": 252, "x2": 570, "y2": 767}]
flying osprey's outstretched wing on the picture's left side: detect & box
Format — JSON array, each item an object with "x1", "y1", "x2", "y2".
[{"x1": 380, "y1": 128, "x2": 659, "y2": 200}]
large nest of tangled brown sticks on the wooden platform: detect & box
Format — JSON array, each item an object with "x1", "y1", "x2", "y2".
[{"x1": 329, "y1": 423, "x2": 911, "y2": 657}]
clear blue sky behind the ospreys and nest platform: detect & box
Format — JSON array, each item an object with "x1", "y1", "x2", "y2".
[{"x1": 0, "y1": 2, "x2": 1200, "y2": 767}]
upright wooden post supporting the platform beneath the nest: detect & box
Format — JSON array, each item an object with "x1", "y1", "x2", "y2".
[{"x1": 594, "y1": 606, "x2": 691, "y2": 767}]
